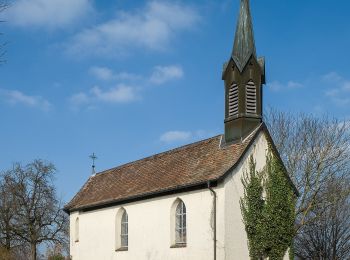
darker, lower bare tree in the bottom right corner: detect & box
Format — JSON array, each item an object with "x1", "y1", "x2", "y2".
[{"x1": 295, "y1": 176, "x2": 350, "y2": 260}]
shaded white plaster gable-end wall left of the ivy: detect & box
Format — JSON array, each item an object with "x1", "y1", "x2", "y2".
[{"x1": 224, "y1": 132, "x2": 268, "y2": 260}]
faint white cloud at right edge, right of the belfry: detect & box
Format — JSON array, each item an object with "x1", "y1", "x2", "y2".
[{"x1": 322, "y1": 72, "x2": 350, "y2": 106}]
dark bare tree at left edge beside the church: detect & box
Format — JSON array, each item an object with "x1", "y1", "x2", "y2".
[{"x1": 1, "y1": 160, "x2": 67, "y2": 260}]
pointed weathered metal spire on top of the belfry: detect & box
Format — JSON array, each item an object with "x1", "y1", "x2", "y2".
[{"x1": 232, "y1": 0, "x2": 256, "y2": 71}]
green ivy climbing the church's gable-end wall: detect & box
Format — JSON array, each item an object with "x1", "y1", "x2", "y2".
[{"x1": 240, "y1": 154, "x2": 296, "y2": 260}]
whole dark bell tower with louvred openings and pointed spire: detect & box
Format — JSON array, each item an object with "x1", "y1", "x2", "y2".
[{"x1": 222, "y1": 0, "x2": 265, "y2": 143}]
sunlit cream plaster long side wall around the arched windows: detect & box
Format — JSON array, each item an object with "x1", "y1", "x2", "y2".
[{"x1": 70, "y1": 188, "x2": 224, "y2": 260}]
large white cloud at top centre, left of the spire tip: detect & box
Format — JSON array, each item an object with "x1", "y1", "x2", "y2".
[{"x1": 66, "y1": 0, "x2": 199, "y2": 56}]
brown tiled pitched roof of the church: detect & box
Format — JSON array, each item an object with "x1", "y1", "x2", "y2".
[{"x1": 65, "y1": 126, "x2": 262, "y2": 212}]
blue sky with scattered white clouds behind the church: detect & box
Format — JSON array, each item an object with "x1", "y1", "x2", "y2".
[{"x1": 0, "y1": 0, "x2": 350, "y2": 201}]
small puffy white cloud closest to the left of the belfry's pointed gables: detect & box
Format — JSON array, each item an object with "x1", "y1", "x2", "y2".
[{"x1": 150, "y1": 65, "x2": 184, "y2": 84}]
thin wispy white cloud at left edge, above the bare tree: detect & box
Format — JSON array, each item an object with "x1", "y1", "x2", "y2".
[{"x1": 0, "y1": 89, "x2": 52, "y2": 111}]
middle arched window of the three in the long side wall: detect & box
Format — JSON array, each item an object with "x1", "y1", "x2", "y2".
[{"x1": 115, "y1": 208, "x2": 129, "y2": 251}]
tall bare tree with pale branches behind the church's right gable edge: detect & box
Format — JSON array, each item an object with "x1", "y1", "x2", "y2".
[{"x1": 265, "y1": 109, "x2": 350, "y2": 230}]
